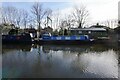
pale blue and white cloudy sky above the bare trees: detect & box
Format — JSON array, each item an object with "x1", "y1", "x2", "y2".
[{"x1": 1, "y1": 0, "x2": 119, "y2": 23}]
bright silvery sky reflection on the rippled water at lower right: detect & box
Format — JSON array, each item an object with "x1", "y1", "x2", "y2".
[{"x1": 73, "y1": 50, "x2": 118, "y2": 78}]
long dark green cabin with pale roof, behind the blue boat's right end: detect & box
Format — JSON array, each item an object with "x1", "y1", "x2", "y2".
[{"x1": 69, "y1": 26, "x2": 108, "y2": 39}]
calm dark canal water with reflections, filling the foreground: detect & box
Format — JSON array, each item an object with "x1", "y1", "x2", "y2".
[{"x1": 2, "y1": 44, "x2": 120, "y2": 78}]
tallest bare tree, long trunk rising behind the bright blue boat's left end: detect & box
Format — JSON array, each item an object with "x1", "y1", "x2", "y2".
[{"x1": 32, "y1": 2, "x2": 47, "y2": 37}]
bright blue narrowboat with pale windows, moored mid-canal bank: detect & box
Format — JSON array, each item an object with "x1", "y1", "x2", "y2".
[{"x1": 38, "y1": 34, "x2": 91, "y2": 44}]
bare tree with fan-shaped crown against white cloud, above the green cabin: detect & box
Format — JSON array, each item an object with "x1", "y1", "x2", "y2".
[{"x1": 73, "y1": 6, "x2": 89, "y2": 28}]
